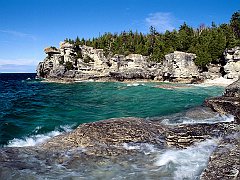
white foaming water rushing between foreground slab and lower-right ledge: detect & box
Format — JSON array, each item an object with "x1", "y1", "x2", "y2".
[{"x1": 154, "y1": 139, "x2": 218, "y2": 180}]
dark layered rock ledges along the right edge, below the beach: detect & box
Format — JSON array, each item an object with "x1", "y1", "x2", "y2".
[{"x1": 202, "y1": 79, "x2": 240, "y2": 179}]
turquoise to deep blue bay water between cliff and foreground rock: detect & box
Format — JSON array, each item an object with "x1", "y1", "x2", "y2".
[{"x1": 0, "y1": 74, "x2": 223, "y2": 146}]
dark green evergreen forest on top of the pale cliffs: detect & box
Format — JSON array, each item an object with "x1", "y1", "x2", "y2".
[{"x1": 65, "y1": 11, "x2": 240, "y2": 68}]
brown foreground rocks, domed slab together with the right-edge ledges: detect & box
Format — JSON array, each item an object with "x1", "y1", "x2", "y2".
[{"x1": 38, "y1": 79, "x2": 240, "y2": 179}]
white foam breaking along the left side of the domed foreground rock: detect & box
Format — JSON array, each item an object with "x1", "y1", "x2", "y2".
[{"x1": 6, "y1": 125, "x2": 73, "y2": 147}]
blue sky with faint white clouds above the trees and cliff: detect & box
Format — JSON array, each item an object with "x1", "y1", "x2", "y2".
[{"x1": 0, "y1": 0, "x2": 240, "y2": 73}]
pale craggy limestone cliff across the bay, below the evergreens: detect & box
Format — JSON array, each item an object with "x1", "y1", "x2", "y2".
[{"x1": 37, "y1": 42, "x2": 202, "y2": 81}]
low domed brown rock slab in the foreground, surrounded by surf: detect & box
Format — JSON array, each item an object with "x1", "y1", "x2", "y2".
[{"x1": 41, "y1": 118, "x2": 236, "y2": 156}]
